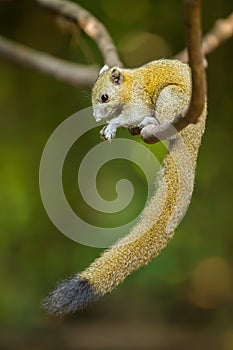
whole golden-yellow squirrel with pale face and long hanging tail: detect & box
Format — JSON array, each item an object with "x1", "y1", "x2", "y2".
[{"x1": 44, "y1": 59, "x2": 206, "y2": 315}]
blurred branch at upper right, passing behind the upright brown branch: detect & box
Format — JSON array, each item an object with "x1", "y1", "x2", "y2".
[{"x1": 175, "y1": 13, "x2": 233, "y2": 62}]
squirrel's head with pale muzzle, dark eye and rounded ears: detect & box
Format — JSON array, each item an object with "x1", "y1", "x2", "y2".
[{"x1": 92, "y1": 65, "x2": 124, "y2": 121}]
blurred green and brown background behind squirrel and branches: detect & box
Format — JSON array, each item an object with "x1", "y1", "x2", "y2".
[{"x1": 0, "y1": 0, "x2": 233, "y2": 350}]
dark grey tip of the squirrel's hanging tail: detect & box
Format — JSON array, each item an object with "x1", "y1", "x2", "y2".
[{"x1": 42, "y1": 275, "x2": 100, "y2": 316}]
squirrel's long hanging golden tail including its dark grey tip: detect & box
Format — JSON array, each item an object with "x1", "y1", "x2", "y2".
[{"x1": 43, "y1": 111, "x2": 206, "y2": 315}]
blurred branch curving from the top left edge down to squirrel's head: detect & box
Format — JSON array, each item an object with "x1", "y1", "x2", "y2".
[{"x1": 37, "y1": 0, "x2": 122, "y2": 67}]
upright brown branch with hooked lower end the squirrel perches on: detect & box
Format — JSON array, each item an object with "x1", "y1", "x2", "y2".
[{"x1": 143, "y1": 0, "x2": 205, "y2": 143}]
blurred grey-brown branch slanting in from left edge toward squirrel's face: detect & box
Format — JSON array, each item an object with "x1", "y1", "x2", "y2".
[{"x1": 0, "y1": 36, "x2": 98, "y2": 87}]
